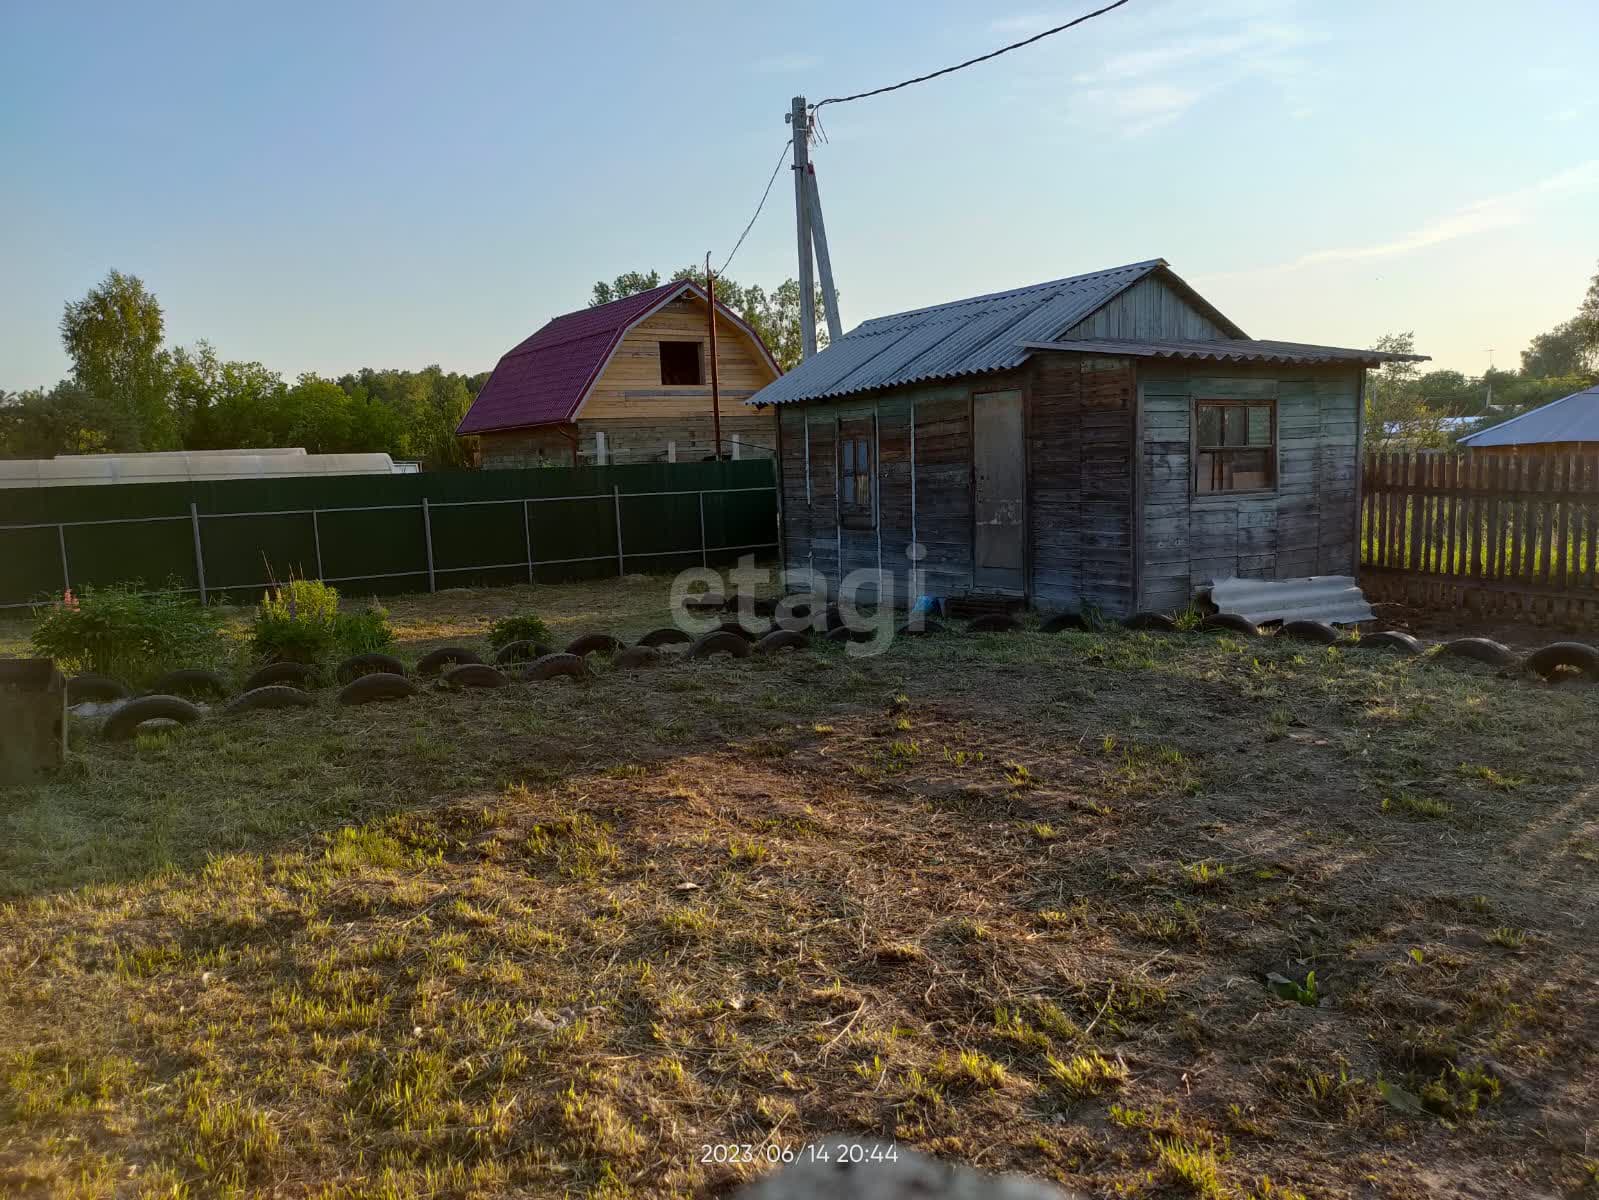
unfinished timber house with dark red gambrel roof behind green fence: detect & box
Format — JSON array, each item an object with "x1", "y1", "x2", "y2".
[{"x1": 456, "y1": 280, "x2": 782, "y2": 467}]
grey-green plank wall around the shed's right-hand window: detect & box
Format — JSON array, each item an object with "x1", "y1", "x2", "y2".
[{"x1": 1137, "y1": 360, "x2": 1361, "y2": 610}]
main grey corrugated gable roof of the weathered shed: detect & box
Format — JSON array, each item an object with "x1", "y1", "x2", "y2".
[{"x1": 748, "y1": 259, "x2": 1244, "y2": 405}]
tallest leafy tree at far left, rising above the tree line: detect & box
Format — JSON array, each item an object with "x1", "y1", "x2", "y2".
[{"x1": 61, "y1": 270, "x2": 177, "y2": 450}]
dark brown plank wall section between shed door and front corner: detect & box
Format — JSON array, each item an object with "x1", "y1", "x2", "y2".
[{"x1": 1027, "y1": 354, "x2": 1135, "y2": 616}]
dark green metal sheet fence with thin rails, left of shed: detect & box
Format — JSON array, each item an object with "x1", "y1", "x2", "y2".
[{"x1": 0, "y1": 459, "x2": 777, "y2": 608}]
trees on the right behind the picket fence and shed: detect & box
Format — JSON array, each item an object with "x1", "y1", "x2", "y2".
[{"x1": 1366, "y1": 259, "x2": 1599, "y2": 450}]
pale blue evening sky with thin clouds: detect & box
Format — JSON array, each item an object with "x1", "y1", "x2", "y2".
[{"x1": 0, "y1": 0, "x2": 1599, "y2": 389}]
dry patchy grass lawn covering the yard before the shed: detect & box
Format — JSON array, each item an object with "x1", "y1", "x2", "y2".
[{"x1": 0, "y1": 579, "x2": 1599, "y2": 1200}]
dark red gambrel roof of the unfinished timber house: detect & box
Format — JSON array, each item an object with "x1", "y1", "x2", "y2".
[{"x1": 456, "y1": 280, "x2": 782, "y2": 434}]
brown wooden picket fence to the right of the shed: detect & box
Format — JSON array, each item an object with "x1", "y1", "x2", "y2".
[{"x1": 1361, "y1": 451, "x2": 1599, "y2": 627}]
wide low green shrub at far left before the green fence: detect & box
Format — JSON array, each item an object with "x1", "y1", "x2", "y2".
[{"x1": 34, "y1": 584, "x2": 227, "y2": 686}]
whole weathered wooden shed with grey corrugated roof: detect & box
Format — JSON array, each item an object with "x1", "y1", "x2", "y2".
[{"x1": 750, "y1": 259, "x2": 1426, "y2": 616}]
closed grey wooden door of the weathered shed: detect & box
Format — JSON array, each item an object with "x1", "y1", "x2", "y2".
[{"x1": 972, "y1": 392, "x2": 1027, "y2": 595}]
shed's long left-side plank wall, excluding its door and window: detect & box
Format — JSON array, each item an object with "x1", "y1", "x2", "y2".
[{"x1": 780, "y1": 355, "x2": 1134, "y2": 616}]
